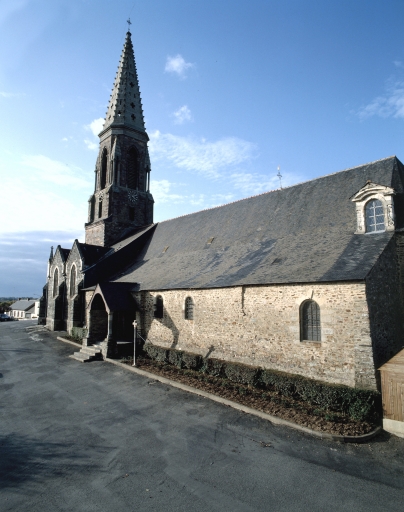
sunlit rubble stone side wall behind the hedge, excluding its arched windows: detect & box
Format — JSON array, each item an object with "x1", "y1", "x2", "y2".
[{"x1": 142, "y1": 283, "x2": 376, "y2": 389}]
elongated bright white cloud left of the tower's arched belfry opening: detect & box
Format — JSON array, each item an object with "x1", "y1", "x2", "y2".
[{"x1": 21, "y1": 155, "x2": 91, "y2": 189}]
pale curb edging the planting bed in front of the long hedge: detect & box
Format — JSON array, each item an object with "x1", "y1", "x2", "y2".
[{"x1": 104, "y1": 358, "x2": 383, "y2": 443}]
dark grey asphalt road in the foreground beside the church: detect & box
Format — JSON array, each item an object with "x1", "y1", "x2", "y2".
[{"x1": 0, "y1": 321, "x2": 404, "y2": 512}]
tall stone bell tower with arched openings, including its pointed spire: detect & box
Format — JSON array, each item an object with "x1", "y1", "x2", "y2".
[{"x1": 85, "y1": 30, "x2": 154, "y2": 247}]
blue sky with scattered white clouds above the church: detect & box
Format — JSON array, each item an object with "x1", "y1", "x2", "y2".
[{"x1": 0, "y1": 0, "x2": 404, "y2": 297}]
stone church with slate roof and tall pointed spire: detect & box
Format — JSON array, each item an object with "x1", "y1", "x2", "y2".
[{"x1": 39, "y1": 32, "x2": 404, "y2": 389}]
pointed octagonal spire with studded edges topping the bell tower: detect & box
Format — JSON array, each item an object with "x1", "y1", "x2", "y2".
[{"x1": 103, "y1": 31, "x2": 145, "y2": 132}]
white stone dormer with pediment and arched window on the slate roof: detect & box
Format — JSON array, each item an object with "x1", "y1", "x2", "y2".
[{"x1": 351, "y1": 180, "x2": 395, "y2": 234}]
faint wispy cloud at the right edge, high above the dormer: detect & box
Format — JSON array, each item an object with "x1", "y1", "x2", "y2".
[{"x1": 358, "y1": 79, "x2": 404, "y2": 119}]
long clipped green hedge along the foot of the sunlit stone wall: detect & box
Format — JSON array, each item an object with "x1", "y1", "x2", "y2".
[{"x1": 144, "y1": 344, "x2": 381, "y2": 421}]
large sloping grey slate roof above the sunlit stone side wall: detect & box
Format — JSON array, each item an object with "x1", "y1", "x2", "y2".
[{"x1": 103, "y1": 157, "x2": 404, "y2": 290}]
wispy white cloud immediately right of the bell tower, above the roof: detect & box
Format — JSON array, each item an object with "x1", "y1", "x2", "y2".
[{"x1": 150, "y1": 130, "x2": 256, "y2": 179}]
